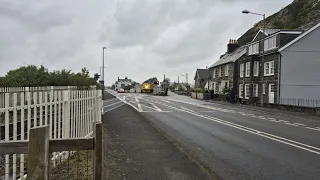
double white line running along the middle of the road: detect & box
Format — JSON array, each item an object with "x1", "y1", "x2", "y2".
[{"x1": 149, "y1": 102, "x2": 320, "y2": 155}]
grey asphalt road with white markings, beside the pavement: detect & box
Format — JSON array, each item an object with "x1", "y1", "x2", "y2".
[{"x1": 104, "y1": 91, "x2": 320, "y2": 180}]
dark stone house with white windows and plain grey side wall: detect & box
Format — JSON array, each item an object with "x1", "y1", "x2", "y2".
[{"x1": 237, "y1": 24, "x2": 320, "y2": 106}]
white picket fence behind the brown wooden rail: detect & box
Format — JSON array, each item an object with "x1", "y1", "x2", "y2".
[{"x1": 0, "y1": 88, "x2": 102, "y2": 180}]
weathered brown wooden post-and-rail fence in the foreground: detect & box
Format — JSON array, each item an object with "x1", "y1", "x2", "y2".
[{"x1": 0, "y1": 122, "x2": 103, "y2": 180}]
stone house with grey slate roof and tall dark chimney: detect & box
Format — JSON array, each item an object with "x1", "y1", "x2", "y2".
[{"x1": 209, "y1": 40, "x2": 246, "y2": 94}]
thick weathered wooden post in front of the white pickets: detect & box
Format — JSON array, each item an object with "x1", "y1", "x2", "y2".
[{"x1": 27, "y1": 126, "x2": 50, "y2": 180}]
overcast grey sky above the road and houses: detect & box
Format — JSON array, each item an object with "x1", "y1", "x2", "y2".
[{"x1": 0, "y1": 0, "x2": 292, "y2": 85}]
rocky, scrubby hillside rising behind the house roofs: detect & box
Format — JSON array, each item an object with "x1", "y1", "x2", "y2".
[{"x1": 238, "y1": 0, "x2": 320, "y2": 45}]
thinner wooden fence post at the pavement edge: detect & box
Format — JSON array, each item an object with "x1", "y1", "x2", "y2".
[{"x1": 93, "y1": 122, "x2": 103, "y2": 180}]
